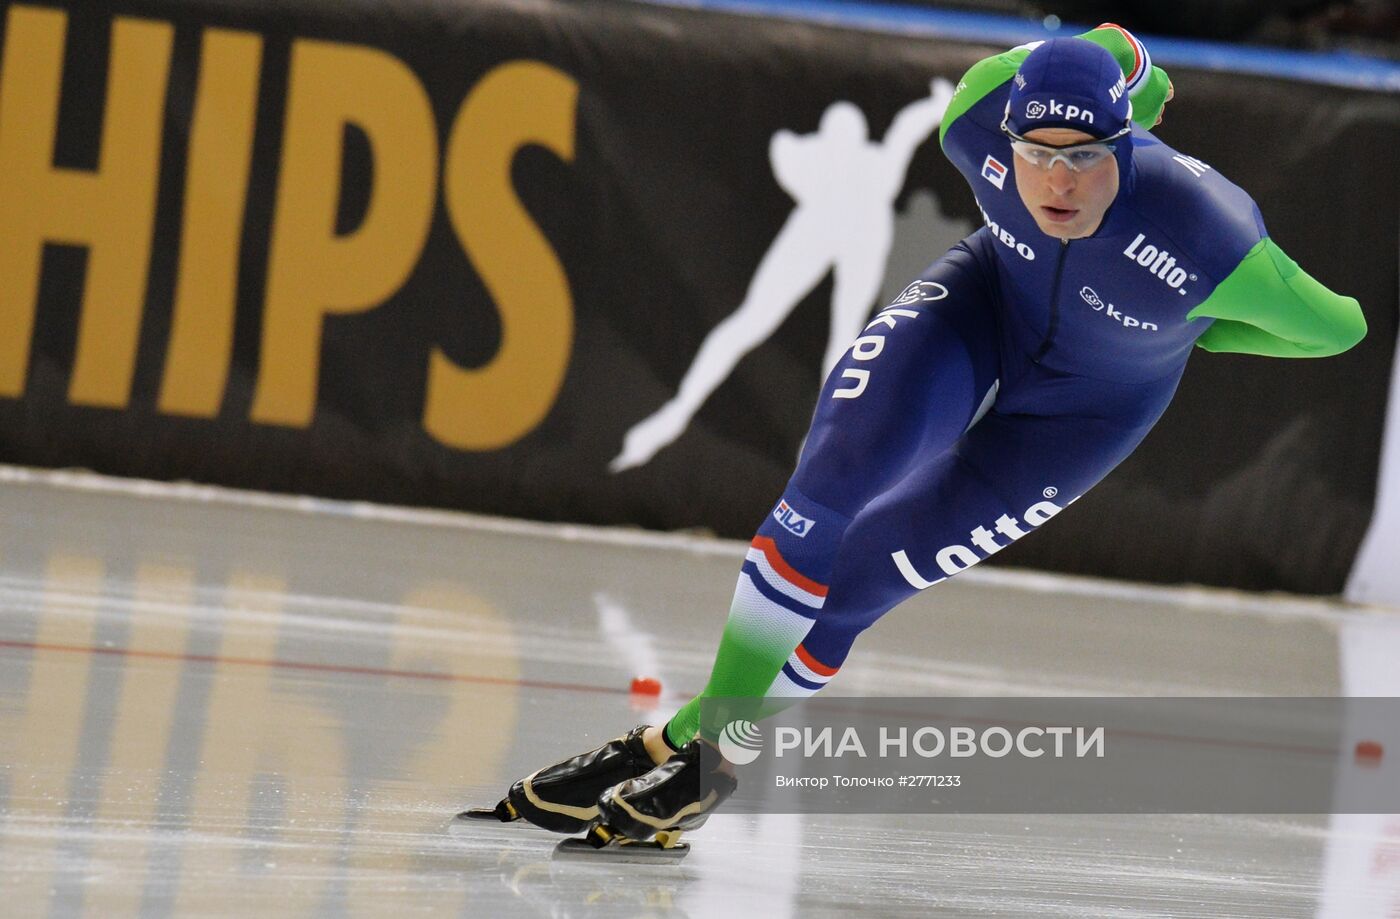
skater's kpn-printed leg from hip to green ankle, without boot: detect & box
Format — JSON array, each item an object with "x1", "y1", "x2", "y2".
[{"x1": 666, "y1": 247, "x2": 998, "y2": 747}]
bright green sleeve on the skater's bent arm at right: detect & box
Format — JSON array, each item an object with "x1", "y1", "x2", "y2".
[{"x1": 1186, "y1": 237, "x2": 1366, "y2": 357}]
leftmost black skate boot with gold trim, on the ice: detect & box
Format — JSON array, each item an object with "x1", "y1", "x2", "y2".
[{"x1": 458, "y1": 724, "x2": 655, "y2": 834}]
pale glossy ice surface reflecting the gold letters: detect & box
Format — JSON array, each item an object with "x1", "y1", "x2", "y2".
[{"x1": 0, "y1": 481, "x2": 1400, "y2": 919}]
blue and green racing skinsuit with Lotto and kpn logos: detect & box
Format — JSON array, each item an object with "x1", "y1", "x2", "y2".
[{"x1": 668, "y1": 27, "x2": 1365, "y2": 741}]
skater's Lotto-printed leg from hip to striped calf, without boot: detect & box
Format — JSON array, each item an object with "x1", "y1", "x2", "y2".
[{"x1": 767, "y1": 361, "x2": 1176, "y2": 699}]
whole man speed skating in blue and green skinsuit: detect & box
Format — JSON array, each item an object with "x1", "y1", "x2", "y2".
[{"x1": 473, "y1": 25, "x2": 1366, "y2": 845}]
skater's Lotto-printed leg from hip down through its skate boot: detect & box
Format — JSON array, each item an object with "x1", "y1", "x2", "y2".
[{"x1": 598, "y1": 358, "x2": 1176, "y2": 838}]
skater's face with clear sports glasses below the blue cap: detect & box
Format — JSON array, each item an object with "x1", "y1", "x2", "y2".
[{"x1": 1011, "y1": 127, "x2": 1119, "y2": 240}]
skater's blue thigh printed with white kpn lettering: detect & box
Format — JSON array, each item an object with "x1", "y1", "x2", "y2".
[{"x1": 792, "y1": 244, "x2": 1000, "y2": 516}]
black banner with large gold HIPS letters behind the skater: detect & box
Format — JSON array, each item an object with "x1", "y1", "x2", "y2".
[{"x1": 0, "y1": 0, "x2": 1400, "y2": 593}]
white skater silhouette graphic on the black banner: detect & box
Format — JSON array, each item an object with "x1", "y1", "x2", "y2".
[{"x1": 609, "y1": 78, "x2": 953, "y2": 472}]
